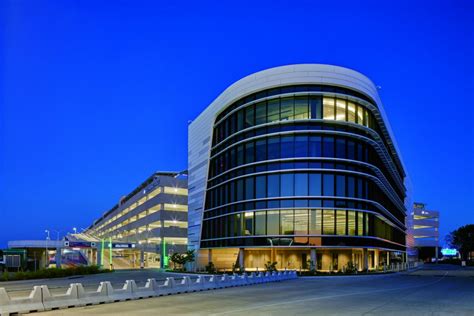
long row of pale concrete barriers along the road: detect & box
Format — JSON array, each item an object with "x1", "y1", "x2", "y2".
[{"x1": 0, "y1": 271, "x2": 297, "y2": 316}]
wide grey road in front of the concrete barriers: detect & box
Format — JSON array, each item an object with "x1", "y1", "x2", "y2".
[{"x1": 36, "y1": 265, "x2": 474, "y2": 316}]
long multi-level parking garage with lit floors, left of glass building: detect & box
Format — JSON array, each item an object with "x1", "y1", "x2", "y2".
[{"x1": 82, "y1": 172, "x2": 188, "y2": 268}]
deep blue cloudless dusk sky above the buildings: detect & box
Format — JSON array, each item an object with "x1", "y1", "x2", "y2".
[{"x1": 0, "y1": 0, "x2": 474, "y2": 248}]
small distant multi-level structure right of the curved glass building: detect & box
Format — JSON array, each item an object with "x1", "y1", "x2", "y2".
[{"x1": 407, "y1": 202, "x2": 439, "y2": 261}]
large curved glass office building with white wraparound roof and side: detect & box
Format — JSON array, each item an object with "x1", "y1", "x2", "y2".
[{"x1": 188, "y1": 64, "x2": 410, "y2": 271}]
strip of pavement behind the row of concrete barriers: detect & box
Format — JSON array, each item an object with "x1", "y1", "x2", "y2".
[{"x1": 0, "y1": 269, "x2": 194, "y2": 297}]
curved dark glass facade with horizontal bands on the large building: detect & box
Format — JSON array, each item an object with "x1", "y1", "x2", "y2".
[{"x1": 201, "y1": 85, "x2": 405, "y2": 258}]
